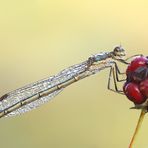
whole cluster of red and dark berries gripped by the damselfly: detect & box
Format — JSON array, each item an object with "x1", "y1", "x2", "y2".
[{"x1": 123, "y1": 56, "x2": 148, "y2": 104}]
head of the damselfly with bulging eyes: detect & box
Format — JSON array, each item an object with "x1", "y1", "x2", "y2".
[{"x1": 113, "y1": 45, "x2": 126, "y2": 59}]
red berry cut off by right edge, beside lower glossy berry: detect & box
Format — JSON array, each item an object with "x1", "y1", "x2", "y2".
[{"x1": 140, "y1": 78, "x2": 148, "y2": 98}]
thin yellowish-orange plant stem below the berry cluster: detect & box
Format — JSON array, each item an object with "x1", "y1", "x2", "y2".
[{"x1": 129, "y1": 109, "x2": 147, "y2": 148}]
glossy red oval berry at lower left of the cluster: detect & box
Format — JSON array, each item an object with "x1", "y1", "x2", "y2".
[{"x1": 123, "y1": 82, "x2": 146, "y2": 104}]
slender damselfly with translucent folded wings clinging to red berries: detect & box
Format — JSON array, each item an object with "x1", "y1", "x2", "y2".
[{"x1": 0, "y1": 46, "x2": 134, "y2": 117}]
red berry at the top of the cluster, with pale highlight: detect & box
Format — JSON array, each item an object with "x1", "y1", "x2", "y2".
[{"x1": 126, "y1": 56, "x2": 148, "y2": 75}]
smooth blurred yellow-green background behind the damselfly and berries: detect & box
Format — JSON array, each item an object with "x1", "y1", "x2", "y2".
[{"x1": 0, "y1": 0, "x2": 148, "y2": 148}]
